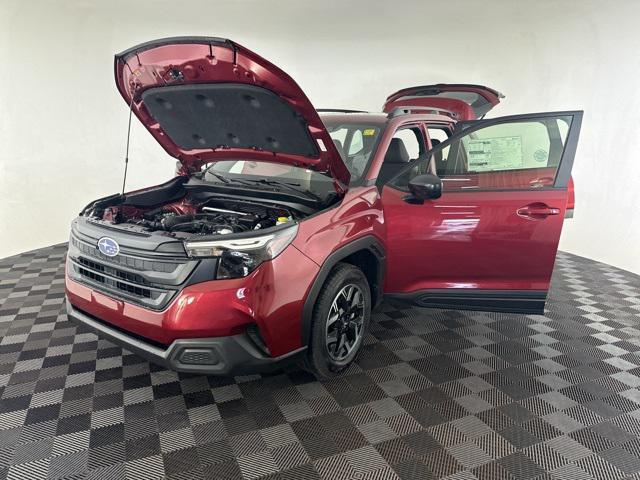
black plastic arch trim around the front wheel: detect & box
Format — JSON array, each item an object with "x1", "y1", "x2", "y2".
[{"x1": 301, "y1": 235, "x2": 386, "y2": 346}]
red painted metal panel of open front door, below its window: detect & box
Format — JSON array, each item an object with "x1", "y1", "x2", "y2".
[{"x1": 382, "y1": 186, "x2": 566, "y2": 293}]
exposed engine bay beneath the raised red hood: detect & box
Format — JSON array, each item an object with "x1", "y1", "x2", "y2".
[{"x1": 80, "y1": 177, "x2": 333, "y2": 240}]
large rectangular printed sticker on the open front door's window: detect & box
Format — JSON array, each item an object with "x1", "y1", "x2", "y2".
[{"x1": 464, "y1": 136, "x2": 523, "y2": 172}]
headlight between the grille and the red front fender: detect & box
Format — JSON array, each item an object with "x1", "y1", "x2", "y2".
[{"x1": 185, "y1": 224, "x2": 298, "y2": 278}]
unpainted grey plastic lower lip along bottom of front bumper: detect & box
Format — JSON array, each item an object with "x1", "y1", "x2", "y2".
[{"x1": 67, "y1": 299, "x2": 306, "y2": 375}]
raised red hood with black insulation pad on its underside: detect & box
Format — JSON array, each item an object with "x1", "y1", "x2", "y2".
[{"x1": 115, "y1": 37, "x2": 350, "y2": 193}]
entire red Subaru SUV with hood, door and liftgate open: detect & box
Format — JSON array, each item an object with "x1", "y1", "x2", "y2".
[{"x1": 66, "y1": 37, "x2": 582, "y2": 377}]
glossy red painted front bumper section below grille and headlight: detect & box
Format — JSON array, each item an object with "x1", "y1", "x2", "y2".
[{"x1": 65, "y1": 238, "x2": 318, "y2": 357}]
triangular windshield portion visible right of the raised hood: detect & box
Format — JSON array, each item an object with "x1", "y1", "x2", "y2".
[{"x1": 322, "y1": 118, "x2": 381, "y2": 185}]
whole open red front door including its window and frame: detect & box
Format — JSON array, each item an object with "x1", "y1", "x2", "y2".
[{"x1": 382, "y1": 112, "x2": 582, "y2": 313}]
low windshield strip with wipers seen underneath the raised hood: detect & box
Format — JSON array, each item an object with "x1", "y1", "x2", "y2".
[{"x1": 203, "y1": 160, "x2": 335, "y2": 200}]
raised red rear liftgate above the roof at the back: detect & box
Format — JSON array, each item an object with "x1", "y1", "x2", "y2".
[{"x1": 382, "y1": 83, "x2": 504, "y2": 121}]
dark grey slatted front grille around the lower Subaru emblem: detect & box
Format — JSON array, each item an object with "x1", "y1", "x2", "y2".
[{"x1": 69, "y1": 235, "x2": 195, "y2": 310}]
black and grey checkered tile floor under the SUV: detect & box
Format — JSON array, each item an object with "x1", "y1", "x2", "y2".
[{"x1": 0, "y1": 245, "x2": 640, "y2": 480}]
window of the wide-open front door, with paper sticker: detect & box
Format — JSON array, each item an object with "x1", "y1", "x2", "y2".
[{"x1": 394, "y1": 116, "x2": 571, "y2": 191}]
